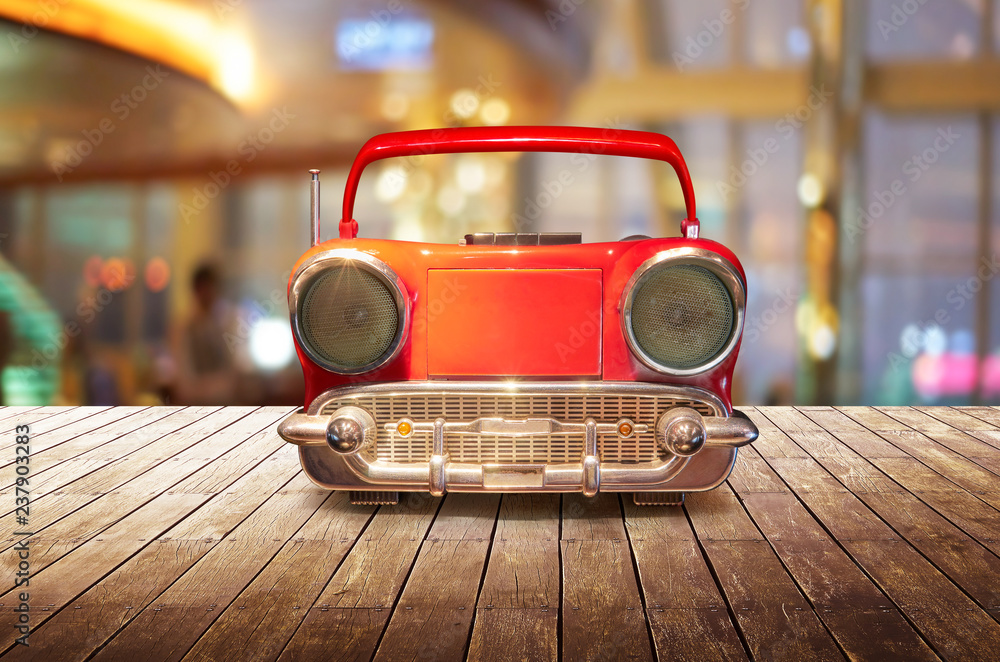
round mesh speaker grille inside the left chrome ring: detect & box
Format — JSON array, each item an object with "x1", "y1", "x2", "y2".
[{"x1": 299, "y1": 265, "x2": 400, "y2": 371}]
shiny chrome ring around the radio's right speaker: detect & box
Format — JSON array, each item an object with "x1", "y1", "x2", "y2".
[{"x1": 619, "y1": 247, "x2": 746, "y2": 377}]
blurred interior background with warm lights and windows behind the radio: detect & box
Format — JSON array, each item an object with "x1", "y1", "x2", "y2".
[{"x1": 0, "y1": 0, "x2": 1000, "y2": 404}]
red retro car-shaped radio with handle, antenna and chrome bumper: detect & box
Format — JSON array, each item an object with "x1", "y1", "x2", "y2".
[{"x1": 278, "y1": 127, "x2": 757, "y2": 504}]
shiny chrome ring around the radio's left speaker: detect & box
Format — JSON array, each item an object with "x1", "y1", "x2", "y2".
[{"x1": 288, "y1": 249, "x2": 410, "y2": 375}]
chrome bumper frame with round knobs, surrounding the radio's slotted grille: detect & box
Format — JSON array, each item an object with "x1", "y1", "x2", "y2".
[{"x1": 278, "y1": 382, "x2": 757, "y2": 496}]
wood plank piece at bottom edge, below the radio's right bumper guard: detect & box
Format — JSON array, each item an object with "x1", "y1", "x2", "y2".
[{"x1": 561, "y1": 544, "x2": 653, "y2": 660}]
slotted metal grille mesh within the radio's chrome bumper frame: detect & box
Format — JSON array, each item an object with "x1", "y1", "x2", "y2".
[{"x1": 319, "y1": 392, "x2": 717, "y2": 464}]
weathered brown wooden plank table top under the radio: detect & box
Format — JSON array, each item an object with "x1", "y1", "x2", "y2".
[{"x1": 0, "y1": 407, "x2": 1000, "y2": 662}]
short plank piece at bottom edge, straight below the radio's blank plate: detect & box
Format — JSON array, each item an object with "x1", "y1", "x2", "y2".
[{"x1": 467, "y1": 608, "x2": 559, "y2": 662}]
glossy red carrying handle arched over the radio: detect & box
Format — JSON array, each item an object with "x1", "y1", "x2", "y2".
[{"x1": 340, "y1": 126, "x2": 700, "y2": 239}]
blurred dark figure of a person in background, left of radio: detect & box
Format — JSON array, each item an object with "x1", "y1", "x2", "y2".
[{"x1": 170, "y1": 263, "x2": 239, "y2": 405}]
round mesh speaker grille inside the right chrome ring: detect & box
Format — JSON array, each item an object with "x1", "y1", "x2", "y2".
[{"x1": 631, "y1": 264, "x2": 735, "y2": 370}]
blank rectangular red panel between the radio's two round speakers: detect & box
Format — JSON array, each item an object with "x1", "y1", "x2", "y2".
[{"x1": 424, "y1": 269, "x2": 603, "y2": 377}]
